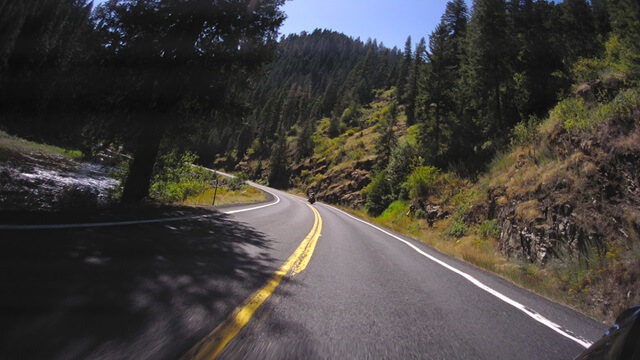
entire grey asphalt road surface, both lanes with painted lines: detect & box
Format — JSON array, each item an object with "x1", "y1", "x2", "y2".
[{"x1": 0, "y1": 184, "x2": 606, "y2": 359}]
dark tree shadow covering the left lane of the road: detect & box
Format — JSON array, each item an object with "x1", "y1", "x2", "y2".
[{"x1": 0, "y1": 213, "x2": 294, "y2": 359}]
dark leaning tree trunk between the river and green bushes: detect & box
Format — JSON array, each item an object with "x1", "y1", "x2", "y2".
[{"x1": 121, "y1": 124, "x2": 164, "y2": 204}]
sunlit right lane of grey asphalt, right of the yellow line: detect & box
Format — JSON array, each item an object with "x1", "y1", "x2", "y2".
[{"x1": 214, "y1": 186, "x2": 606, "y2": 359}]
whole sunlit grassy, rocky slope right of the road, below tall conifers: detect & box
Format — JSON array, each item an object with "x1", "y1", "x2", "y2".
[{"x1": 226, "y1": 33, "x2": 640, "y2": 321}]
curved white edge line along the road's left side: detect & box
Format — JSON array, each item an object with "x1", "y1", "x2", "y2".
[{"x1": 0, "y1": 180, "x2": 280, "y2": 230}]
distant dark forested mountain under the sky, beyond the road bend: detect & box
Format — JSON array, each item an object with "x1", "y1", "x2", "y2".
[{"x1": 198, "y1": 29, "x2": 400, "y2": 162}]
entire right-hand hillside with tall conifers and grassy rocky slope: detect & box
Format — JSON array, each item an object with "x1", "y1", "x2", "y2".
[{"x1": 220, "y1": 0, "x2": 640, "y2": 322}]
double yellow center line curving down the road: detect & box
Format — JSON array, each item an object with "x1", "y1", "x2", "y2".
[{"x1": 182, "y1": 205, "x2": 322, "y2": 360}]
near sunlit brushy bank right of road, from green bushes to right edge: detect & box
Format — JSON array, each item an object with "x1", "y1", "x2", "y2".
[{"x1": 330, "y1": 31, "x2": 640, "y2": 322}]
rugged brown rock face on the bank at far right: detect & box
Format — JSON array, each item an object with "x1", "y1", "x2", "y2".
[{"x1": 487, "y1": 112, "x2": 640, "y2": 264}]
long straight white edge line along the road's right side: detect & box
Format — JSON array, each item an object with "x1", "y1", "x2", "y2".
[{"x1": 329, "y1": 206, "x2": 593, "y2": 348}]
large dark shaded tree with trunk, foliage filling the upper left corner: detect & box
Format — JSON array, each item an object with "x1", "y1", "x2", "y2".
[{"x1": 0, "y1": 0, "x2": 285, "y2": 203}]
